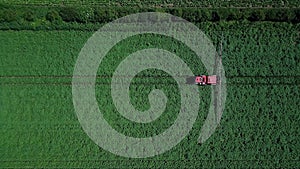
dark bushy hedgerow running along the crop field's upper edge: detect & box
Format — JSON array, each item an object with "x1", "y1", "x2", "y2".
[{"x1": 0, "y1": 4, "x2": 300, "y2": 30}]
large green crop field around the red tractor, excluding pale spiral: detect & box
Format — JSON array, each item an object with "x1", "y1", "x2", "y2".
[{"x1": 0, "y1": 0, "x2": 300, "y2": 168}]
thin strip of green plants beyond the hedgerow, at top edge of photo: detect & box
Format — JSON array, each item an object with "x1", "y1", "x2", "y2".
[{"x1": 2, "y1": 0, "x2": 300, "y2": 7}]
